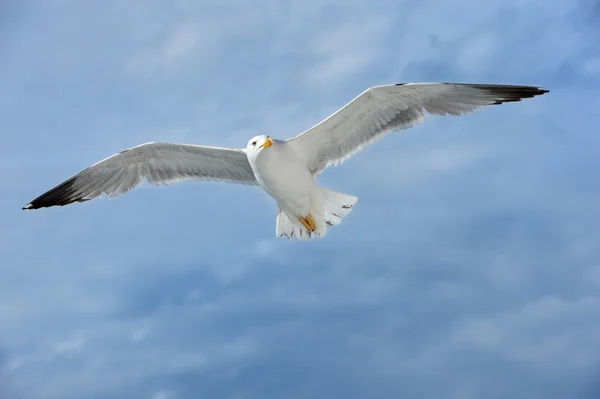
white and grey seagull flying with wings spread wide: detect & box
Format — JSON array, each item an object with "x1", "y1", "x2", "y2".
[{"x1": 23, "y1": 82, "x2": 548, "y2": 239}]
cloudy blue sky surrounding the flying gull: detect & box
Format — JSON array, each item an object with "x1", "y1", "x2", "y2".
[{"x1": 0, "y1": 0, "x2": 600, "y2": 399}]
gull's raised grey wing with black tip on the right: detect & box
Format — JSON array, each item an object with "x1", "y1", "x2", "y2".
[{"x1": 287, "y1": 83, "x2": 548, "y2": 175}]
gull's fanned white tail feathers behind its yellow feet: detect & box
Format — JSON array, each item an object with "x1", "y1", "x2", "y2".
[{"x1": 275, "y1": 187, "x2": 358, "y2": 239}]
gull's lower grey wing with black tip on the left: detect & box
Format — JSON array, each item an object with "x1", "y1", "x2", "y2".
[{"x1": 23, "y1": 142, "x2": 258, "y2": 209}]
